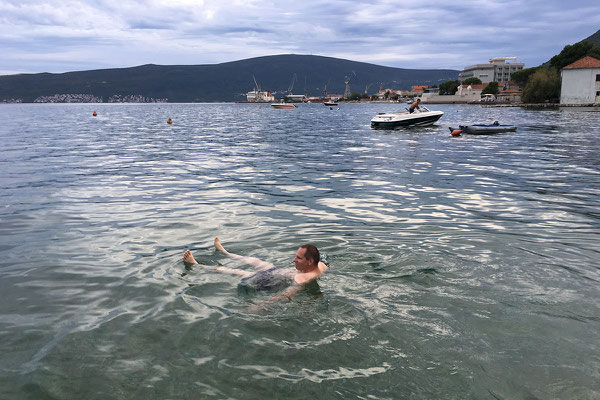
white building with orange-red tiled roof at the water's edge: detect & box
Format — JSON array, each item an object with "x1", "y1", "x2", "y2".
[{"x1": 560, "y1": 56, "x2": 600, "y2": 105}]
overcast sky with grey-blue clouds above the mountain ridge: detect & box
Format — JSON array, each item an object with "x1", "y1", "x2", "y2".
[{"x1": 0, "y1": 0, "x2": 600, "y2": 74}]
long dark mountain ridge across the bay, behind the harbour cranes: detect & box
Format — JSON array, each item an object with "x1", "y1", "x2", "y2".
[{"x1": 0, "y1": 54, "x2": 459, "y2": 103}]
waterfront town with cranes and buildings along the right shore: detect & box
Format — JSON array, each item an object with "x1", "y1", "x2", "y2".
[{"x1": 251, "y1": 51, "x2": 600, "y2": 107}]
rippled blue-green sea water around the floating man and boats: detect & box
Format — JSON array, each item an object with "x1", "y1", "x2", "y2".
[{"x1": 0, "y1": 104, "x2": 600, "y2": 400}]
